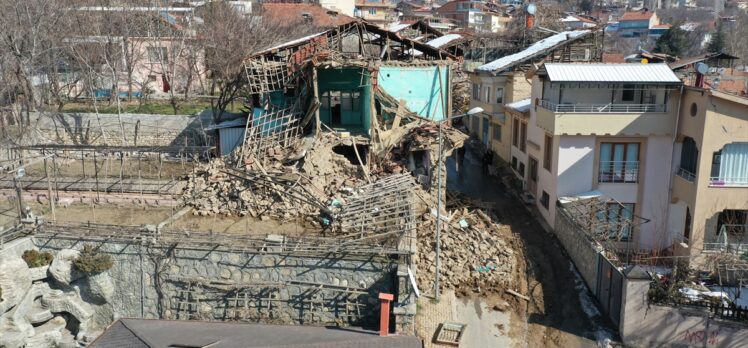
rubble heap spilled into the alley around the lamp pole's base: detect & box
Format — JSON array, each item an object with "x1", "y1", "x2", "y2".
[{"x1": 417, "y1": 208, "x2": 517, "y2": 295}]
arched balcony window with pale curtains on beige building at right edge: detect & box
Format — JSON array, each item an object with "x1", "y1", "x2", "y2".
[{"x1": 709, "y1": 142, "x2": 748, "y2": 186}]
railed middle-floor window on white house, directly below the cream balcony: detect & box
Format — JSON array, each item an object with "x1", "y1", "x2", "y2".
[{"x1": 597, "y1": 143, "x2": 639, "y2": 183}]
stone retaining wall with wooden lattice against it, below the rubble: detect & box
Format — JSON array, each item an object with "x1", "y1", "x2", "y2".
[{"x1": 34, "y1": 237, "x2": 397, "y2": 325}]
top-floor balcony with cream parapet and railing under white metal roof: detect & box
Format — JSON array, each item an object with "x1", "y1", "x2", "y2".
[{"x1": 537, "y1": 100, "x2": 676, "y2": 136}]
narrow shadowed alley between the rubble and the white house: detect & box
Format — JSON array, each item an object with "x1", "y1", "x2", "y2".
[{"x1": 447, "y1": 145, "x2": 615, "y2": 347}]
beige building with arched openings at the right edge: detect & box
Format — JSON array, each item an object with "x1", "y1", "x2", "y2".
[{"x1": 669, "y1": 87, "x2": 748, "y2": 260}]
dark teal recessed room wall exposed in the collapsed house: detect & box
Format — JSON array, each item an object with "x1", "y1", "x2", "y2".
[{"x1": 317, "y1": 68, "x2": 372, "y2": 134}]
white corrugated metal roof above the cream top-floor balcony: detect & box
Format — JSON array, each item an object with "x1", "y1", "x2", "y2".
[{"x1": 544, "y1": 63, "x2": 681, "y2": 83}]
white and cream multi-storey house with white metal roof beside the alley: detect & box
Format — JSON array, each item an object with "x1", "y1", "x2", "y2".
[{"x1": 524, "y1": 63, "x2": 682, "y2": 249}]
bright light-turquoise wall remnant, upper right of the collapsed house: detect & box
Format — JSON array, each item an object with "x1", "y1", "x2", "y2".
[{"x1": 377, "y1": 66, "x2": 450, "y2": 121}]
